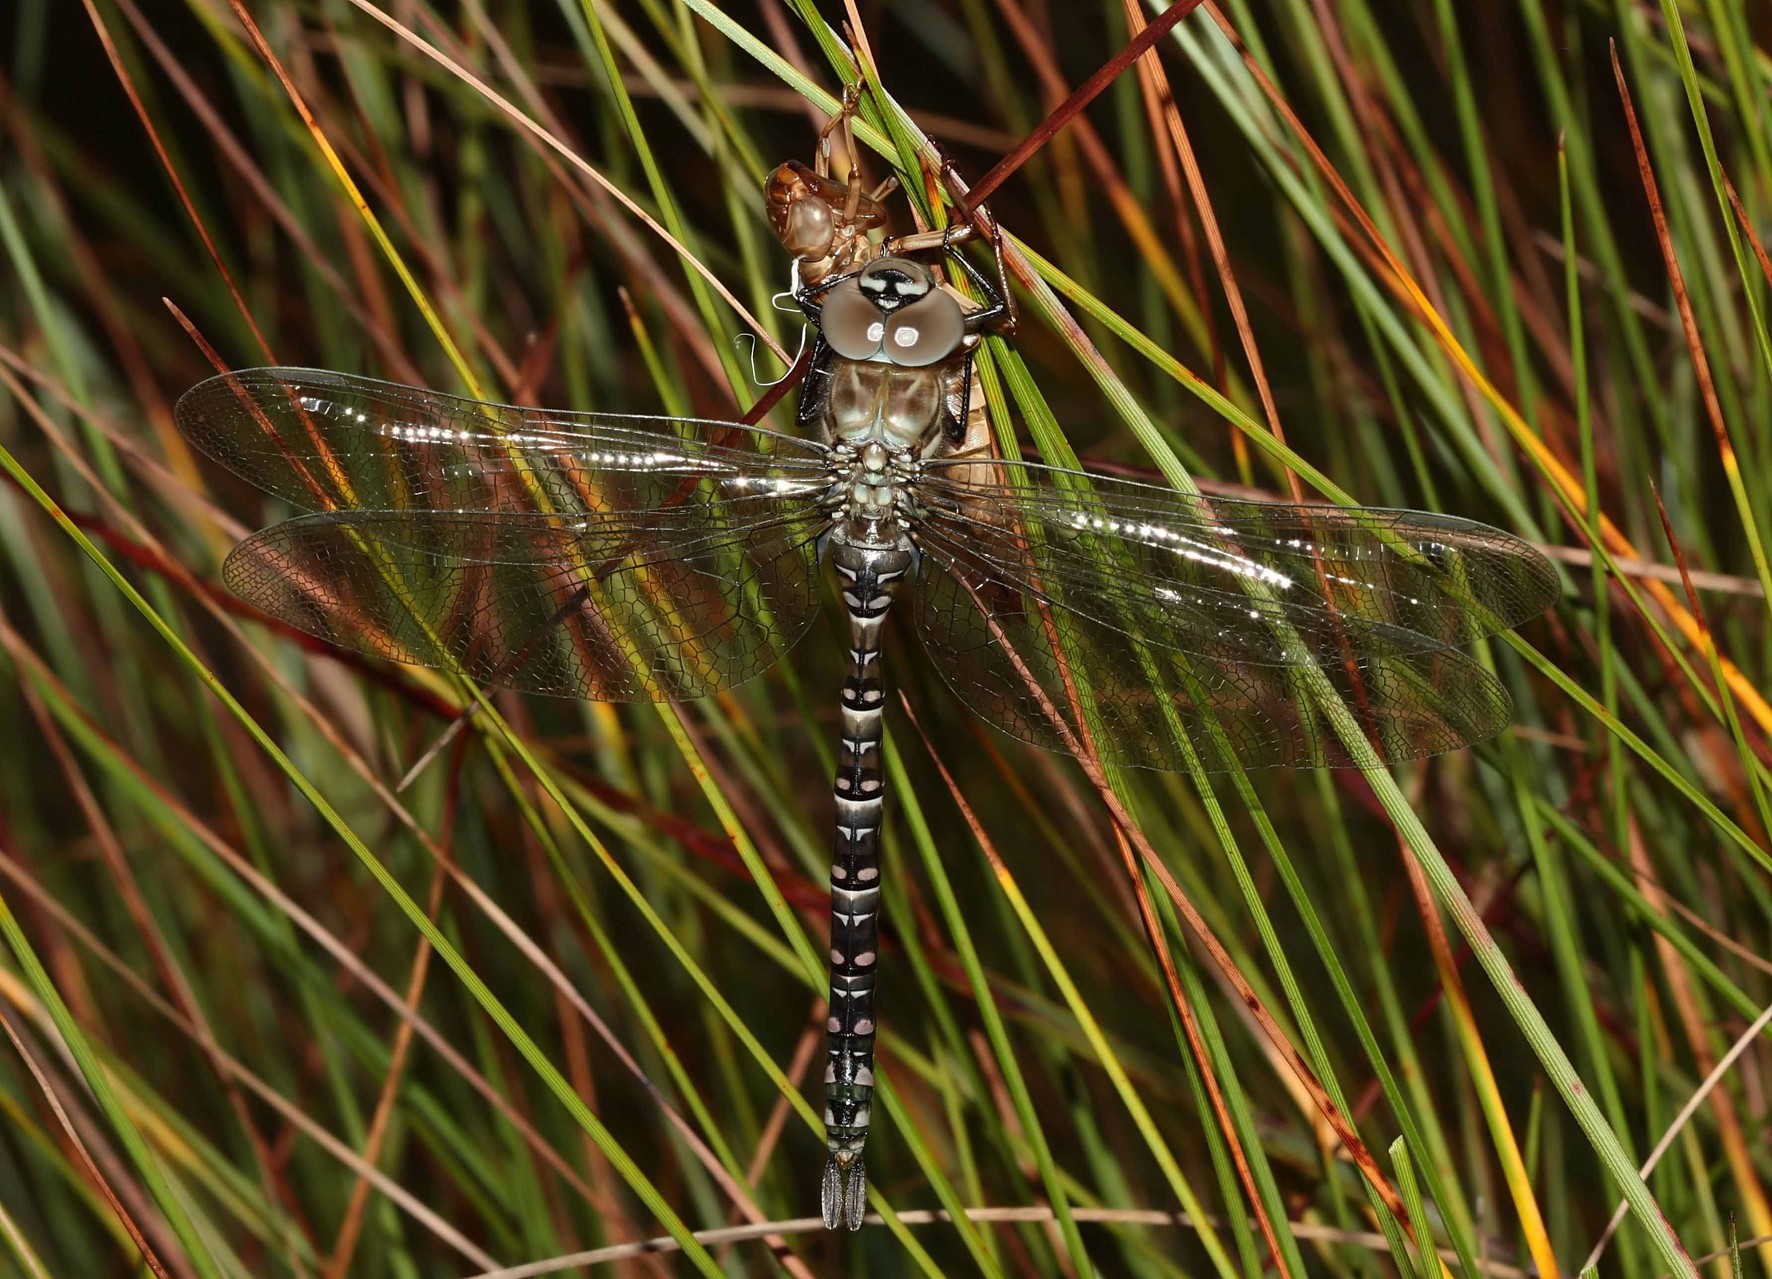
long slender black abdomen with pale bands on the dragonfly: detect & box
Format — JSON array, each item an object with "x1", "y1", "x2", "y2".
[{"x1": 824, "y1": 539, "x2": 913, "y2": 1229}]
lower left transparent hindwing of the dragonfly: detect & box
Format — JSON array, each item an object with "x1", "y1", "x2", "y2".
[{"x1": 223, "y1": 507, "x2": 824, "y2": 702}]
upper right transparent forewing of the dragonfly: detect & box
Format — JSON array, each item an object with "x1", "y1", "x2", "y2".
[{"x1": 916, "y1": 461, "x2": 1559, "y2": 651}]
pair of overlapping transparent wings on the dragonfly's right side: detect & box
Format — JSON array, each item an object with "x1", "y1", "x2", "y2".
[{"x1": 914, "y1": 462, "x2": 1556, "y2": 771}]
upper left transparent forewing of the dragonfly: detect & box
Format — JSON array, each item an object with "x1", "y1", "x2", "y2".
[{"x1": 174, "y1": 368, "x2": 826, "y2": 514}]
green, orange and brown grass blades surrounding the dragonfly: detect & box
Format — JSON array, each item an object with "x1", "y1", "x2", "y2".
[{"x1": 0, "y1": 0, "x2": 1772, "y2": 1279}]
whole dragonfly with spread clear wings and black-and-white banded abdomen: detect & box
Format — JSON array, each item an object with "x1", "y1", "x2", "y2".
[{"x1": 175, "y1": 124, "x2": 1558, "y2": 1229}]
